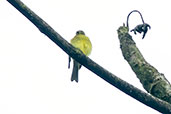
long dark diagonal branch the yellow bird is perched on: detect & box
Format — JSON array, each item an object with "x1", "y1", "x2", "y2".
[{"x1": 7, "y1": 0, "x2": 171, "y2": 113}]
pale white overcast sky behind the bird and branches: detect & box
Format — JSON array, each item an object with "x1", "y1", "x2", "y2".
[{"x1": 0, "y1": 0, "x2": 171, "y2": 114}]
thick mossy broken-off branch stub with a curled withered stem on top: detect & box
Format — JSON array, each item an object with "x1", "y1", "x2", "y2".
[{"x1": 118, "y1": 26, "x2": 171, "y2": 104}]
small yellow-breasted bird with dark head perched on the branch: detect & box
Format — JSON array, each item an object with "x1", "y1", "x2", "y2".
[{"x1": 69, "y1": 30, "x2": 92, "y2": 82}]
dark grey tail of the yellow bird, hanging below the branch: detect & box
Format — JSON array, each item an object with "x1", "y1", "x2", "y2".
[{"x1": 71, "y1": 60, "x2": 80, "y2": 82}]
